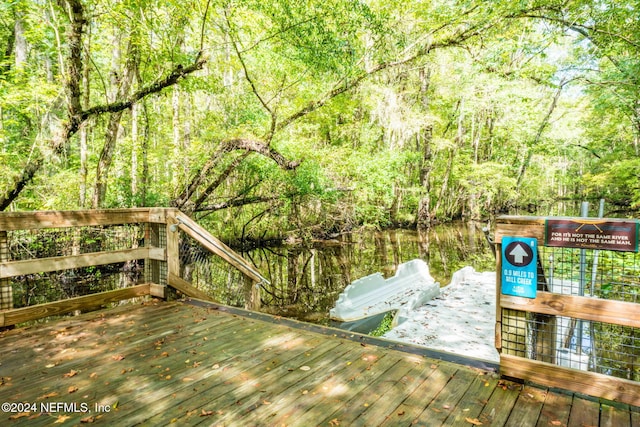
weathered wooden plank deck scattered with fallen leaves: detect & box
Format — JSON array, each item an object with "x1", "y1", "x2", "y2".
[{"x1": 0, "y1": 302, "x2": 640, "y2": 427}]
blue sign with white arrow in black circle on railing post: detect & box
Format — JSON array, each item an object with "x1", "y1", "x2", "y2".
[{"x1": 502, "y1": 236, "x2": 538, "y2": 298}]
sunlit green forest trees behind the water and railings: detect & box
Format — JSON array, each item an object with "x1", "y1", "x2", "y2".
[{"x1": 0, "y1": 0, "x2": 640, "y2": 240}]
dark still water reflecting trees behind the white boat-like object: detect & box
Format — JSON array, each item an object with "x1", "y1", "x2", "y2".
[{"x1": 243, "y1": 223, "x2": 495, "y2": 324}]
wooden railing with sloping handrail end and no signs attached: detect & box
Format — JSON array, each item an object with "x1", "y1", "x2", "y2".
[{"x1": 0, "y1": 208, "x2": 265, "y2": 327}]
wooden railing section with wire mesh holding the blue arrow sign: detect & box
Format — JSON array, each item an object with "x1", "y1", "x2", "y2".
[{"x1": 495, "y1": 216, "x2": 640, "y2": 406}]
